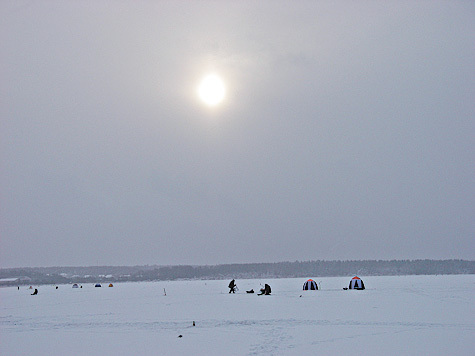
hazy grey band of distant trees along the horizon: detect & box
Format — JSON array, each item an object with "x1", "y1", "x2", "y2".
[{"x1": 0, "y1": 260, "x2": 475, "y2": 286}]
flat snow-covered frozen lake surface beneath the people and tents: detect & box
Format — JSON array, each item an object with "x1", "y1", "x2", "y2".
[{"x1": 0, "y1": 275, "x2": 475, "y2": 356}]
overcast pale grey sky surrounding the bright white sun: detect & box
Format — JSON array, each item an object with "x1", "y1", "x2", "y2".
[{"x1": 0, "y1": 0, "x2": 475, "y2": 268}]
